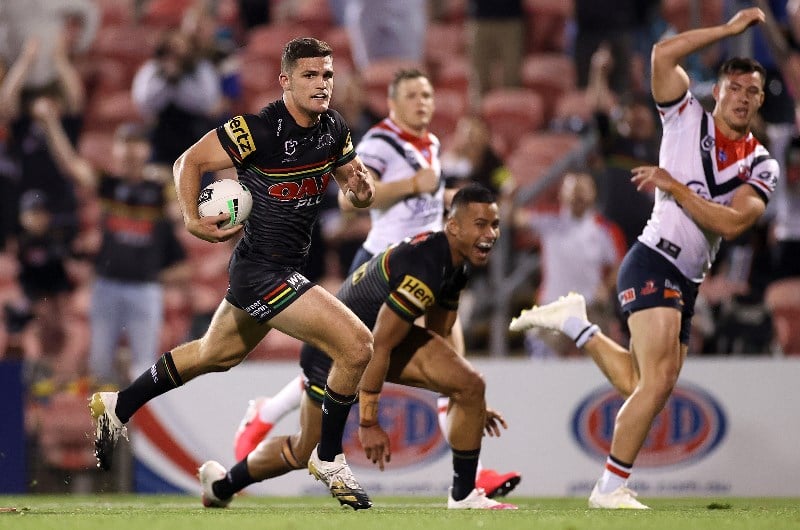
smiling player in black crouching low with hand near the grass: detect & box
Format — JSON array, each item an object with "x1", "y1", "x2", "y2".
[{"x1": 200, "y1": 185, "x2": 516, "y2": 510}]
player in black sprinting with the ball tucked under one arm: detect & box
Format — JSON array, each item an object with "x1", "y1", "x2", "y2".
[{"x1": 90, "y1": 37, "x2": 374, "y2": 509}]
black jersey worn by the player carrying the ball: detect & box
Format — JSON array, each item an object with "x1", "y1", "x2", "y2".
[{"x1": 217, "y1": 100, "x2": 356, "y2": 267}]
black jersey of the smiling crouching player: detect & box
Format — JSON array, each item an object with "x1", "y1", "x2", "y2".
[{"x1": 336, "y1": 232, "x2": 468, "y2": 329}]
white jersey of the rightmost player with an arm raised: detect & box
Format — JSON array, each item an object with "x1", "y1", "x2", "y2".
[{"x1": 639, "y1": 91, "x2": 779, "y2": 282}]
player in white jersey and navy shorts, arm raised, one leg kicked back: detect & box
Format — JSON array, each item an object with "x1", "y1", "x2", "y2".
[{"x1": 511, "y1": 8, "x2": 779, "y2": 509}]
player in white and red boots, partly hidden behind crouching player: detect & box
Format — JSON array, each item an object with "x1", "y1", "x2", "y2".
[{"x1": 234, "y1": 68, "x2": 521, "y2": 497}]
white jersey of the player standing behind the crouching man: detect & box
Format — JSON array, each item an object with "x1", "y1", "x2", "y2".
[{"x1": 356, "y1": 118, "x2": 444, "y2": 254}]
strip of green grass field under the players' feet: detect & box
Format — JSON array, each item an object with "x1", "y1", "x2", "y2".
[{"x1": 0, "y1": 495, "x2": 800, "y2": 530}]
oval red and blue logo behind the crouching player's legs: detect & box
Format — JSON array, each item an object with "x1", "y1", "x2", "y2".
[{"x1": 342, "y1": 384, "x2": 450, "y2": 469}]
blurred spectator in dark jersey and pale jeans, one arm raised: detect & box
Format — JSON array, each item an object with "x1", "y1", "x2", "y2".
[{"x1": 39, "y1": 102, "x2": 188, "y2": 387}]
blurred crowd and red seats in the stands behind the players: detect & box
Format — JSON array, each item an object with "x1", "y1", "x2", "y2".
[{"x1": 0, "y1": 0, "x2": 800, "y2": 486}]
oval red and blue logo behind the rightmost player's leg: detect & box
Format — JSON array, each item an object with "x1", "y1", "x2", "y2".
[{"x1": 572, "y1": 384, "x2": 727, "y2": 468}]
